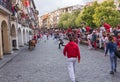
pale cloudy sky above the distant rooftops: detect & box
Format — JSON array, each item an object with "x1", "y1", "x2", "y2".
[{"x1": 34, "y1": 0, "x2": 93, "y2": 16}]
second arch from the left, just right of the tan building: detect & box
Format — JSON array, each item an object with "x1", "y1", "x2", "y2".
[{"x1": 11, "y1": 24, "x2": 17, "y2": 48}]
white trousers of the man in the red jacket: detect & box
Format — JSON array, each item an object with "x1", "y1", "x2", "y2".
[{"x1": 67, "y1": 58, "x2": 77, "y2": 82}]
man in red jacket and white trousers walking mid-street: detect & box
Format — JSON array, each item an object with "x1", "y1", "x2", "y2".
[{"x1": 63, "y1": 37, "x2": 80, "y2": 82}]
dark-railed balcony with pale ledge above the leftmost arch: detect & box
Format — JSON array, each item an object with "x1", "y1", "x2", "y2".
[{"x1": 0, "y1": 0, "x2": 12, "y2": 12}]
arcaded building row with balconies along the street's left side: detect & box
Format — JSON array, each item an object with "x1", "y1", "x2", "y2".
[{"x1": 0, "y1": 0, "x2": 38, "y2": 59}]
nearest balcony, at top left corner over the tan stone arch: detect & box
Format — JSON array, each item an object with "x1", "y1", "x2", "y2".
[{"x1": 0, "y1": 0, "x2": 11, "y2": 14}]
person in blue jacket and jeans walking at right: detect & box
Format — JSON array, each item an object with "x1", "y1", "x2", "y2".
[{"x1": 105, "y1": 36, "x2": 117, "y2": 74}]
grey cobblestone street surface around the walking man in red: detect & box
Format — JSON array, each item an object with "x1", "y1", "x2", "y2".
[{"x1": 0, "y1": 39, "x2": 120, "y2": 82}]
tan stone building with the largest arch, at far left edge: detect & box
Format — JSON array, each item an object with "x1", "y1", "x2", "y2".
[{"x1": 0, "y1": 0, "x2": 12, "y2": 58}]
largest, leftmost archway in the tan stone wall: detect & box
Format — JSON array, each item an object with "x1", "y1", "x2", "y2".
[{"x1": 1, "y1": 21, "x2": 11, "y2": 53}]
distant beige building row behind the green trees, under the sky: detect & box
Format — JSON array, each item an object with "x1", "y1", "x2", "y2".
[{"x1": 39, "y1": 5, "x2": 84, "y2": 29}]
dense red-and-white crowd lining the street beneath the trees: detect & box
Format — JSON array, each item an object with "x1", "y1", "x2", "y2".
[{"x1": 33, "y1": 24, "x2": 120, "y2": 57}]
